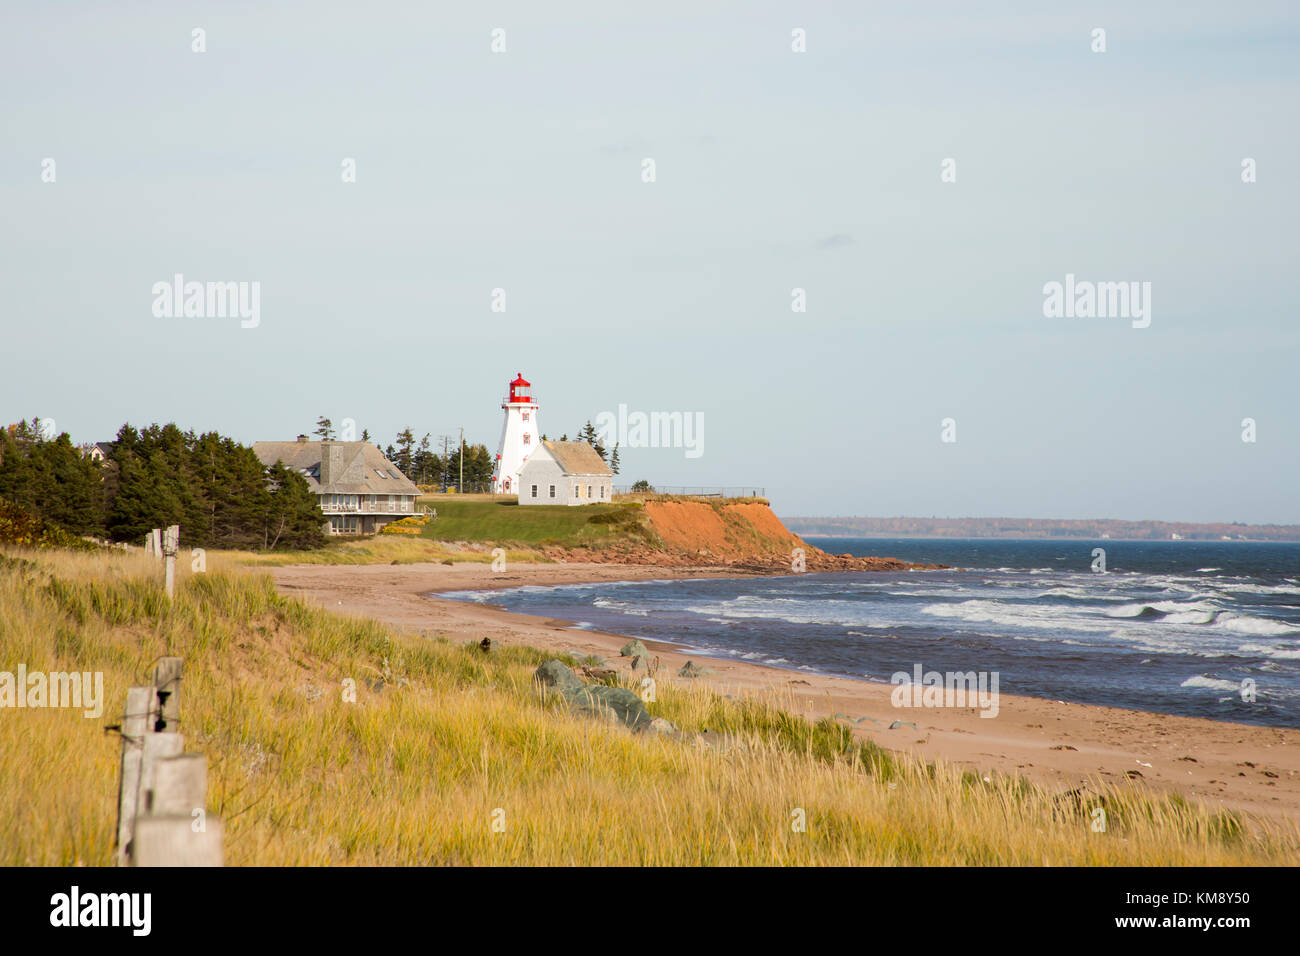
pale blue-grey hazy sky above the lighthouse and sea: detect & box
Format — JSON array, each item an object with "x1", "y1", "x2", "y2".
[{"x1": 0, "y1": 0, "x2": 1300, "y2": 523}]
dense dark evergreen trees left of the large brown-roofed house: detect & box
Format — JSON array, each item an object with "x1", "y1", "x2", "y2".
[{"x1": 0, "y1": 419, "x2": 325, "y2": 549}]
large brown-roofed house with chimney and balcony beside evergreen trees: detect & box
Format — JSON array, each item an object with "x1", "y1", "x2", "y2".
[{"x1": 252, "y1": 438, "x2": 420, "y2": 535}]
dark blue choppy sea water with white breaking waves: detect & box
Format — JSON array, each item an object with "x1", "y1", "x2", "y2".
[{"x1": 439, "y1": 537, "x2": 1300, "y2": 727}]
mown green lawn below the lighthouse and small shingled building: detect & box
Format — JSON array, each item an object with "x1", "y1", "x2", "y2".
[{"x1": 421, "y1": 496, "x2": 641, "y2": 545}]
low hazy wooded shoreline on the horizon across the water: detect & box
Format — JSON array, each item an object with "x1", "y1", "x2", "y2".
[{"x1": 781, "y1": 518, "x2": 1300, "y2": 541}]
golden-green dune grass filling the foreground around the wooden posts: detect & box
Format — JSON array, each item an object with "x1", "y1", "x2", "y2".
[{"x1": 0, "y1": 550, "x2": 1300, "y2": 865}]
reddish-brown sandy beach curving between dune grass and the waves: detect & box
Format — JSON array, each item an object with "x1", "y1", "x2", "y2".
[{"x1": 268, "y1": 563, "x2": 1300, "y2": 821}]
